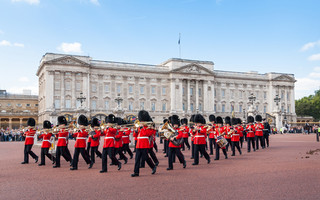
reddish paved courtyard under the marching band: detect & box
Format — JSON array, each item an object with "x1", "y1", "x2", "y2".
[{"x1": 0, "y1": 134, "x2": 320, "y2": 200}]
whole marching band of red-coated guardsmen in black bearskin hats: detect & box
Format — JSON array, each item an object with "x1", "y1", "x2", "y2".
[{"x1": 22, "y1": 110, "x2": 270, "y2": 177}]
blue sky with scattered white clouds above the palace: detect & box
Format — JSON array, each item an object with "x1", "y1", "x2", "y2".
[{"x1": 0, "y1": 0, "x2": 320, "y2": 99}]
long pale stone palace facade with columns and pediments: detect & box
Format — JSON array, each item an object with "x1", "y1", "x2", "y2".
[{"x1": 37, "y1": 53, "x2": 296, "y2": 123}]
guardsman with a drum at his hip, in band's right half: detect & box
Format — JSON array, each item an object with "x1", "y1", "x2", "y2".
[{"x1": 214, "y1": 116, "x2": 228, "y2": 160}]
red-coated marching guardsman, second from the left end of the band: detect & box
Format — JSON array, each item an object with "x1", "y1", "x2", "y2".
[{"x1": 38, "y1": 120, "x2": 55, "y2": 166}]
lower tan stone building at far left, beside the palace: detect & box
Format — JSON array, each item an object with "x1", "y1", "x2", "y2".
[{"x1": 0, "y1": 90, "x2": 38, "y2": 129}]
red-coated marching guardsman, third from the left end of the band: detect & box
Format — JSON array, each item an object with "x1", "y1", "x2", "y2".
[{"x1": 53, "y1": 116, "x2": 72, "y2": 168}]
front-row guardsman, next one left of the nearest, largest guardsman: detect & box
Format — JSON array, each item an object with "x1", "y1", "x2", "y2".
[{"x1": 100, "y1": 114, "x2": 121, "y2": 173}]
